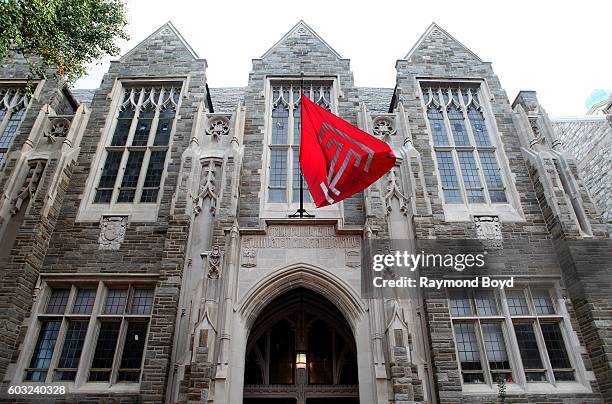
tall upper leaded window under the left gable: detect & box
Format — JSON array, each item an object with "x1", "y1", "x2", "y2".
[{"x1": 93, "y1": 83, "x2": 181, "y2": 204}]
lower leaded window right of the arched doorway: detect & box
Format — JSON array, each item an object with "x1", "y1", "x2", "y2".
[{"x1": 448, "y1": 286, "x2": 576, "y2": 388}]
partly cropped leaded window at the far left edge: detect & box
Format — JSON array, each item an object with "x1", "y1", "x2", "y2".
[{"x1": 0, "y1": 87, "x2": 30, "y2": 167}]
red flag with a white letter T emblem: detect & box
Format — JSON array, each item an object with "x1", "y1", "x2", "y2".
[{"x1": 300, "y1": 94, "x2": 395, "y2": 208}]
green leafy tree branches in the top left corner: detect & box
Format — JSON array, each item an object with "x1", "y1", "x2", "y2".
[{"x1": 0, "y1": 0, "x2": 128, "y2": 83}]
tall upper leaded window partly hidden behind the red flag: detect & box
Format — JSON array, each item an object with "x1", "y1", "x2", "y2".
[{"x1": 268, "y1": 81, "x2": 333, "y2": 203}]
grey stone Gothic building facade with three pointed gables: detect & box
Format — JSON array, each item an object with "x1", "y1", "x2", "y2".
[{"x1": 0, "y1": 21, "x2": 612, "y2": 404}]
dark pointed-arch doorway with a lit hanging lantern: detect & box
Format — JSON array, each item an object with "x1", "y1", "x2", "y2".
[{"x1": 243, "y1": 288, "x2": 359, "y2": 404}]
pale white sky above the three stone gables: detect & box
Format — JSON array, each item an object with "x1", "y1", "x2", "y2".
[{"x1": 75, "y1": 0, "x2": 612, "y2": 117}]
